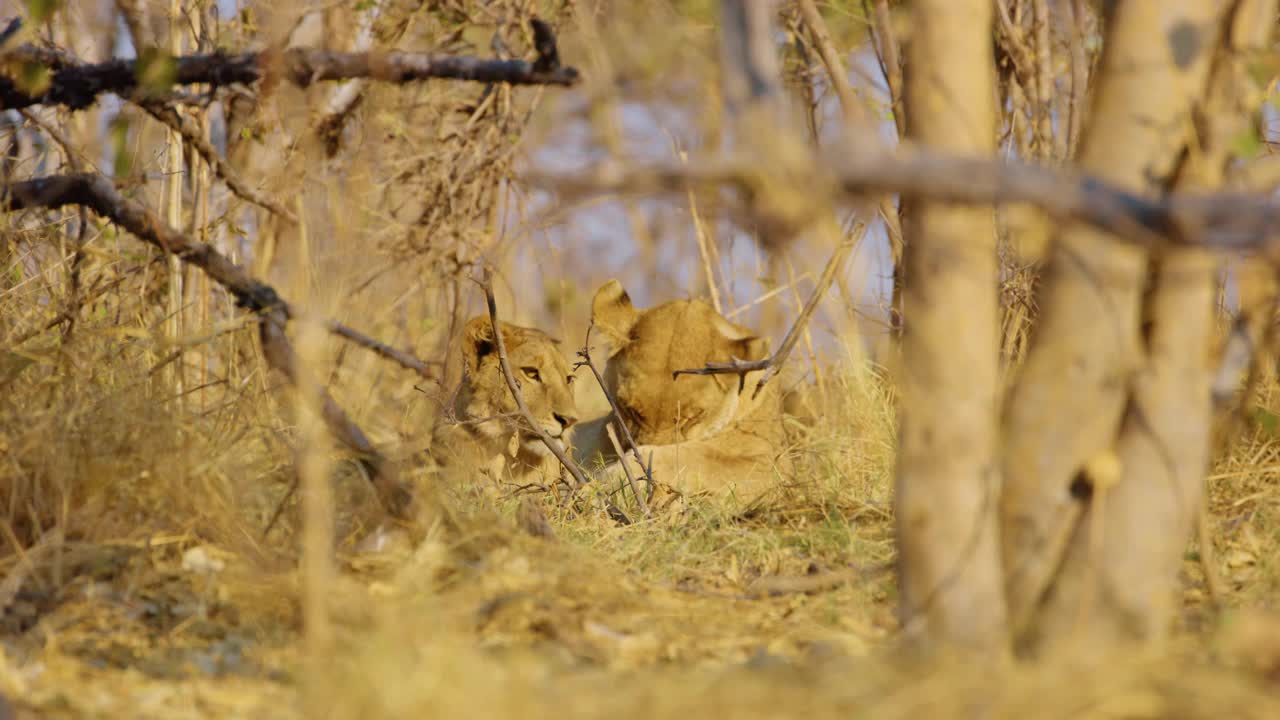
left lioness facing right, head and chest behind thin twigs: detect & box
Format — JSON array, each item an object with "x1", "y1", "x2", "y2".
[{"x1": 431, "y1": 315, "x2": 577, "y2": 479}]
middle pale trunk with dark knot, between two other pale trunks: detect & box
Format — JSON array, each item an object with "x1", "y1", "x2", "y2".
[{"x1": 1001, "y1": 0, "x2": 1220, "y2": 651}]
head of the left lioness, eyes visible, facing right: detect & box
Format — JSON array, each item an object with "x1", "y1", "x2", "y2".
[{"x1": 453, "y1": 315, "x2": 577, "y2": 465}]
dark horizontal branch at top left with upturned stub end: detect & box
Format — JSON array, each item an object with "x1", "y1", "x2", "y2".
[{"x1": 0, "y1": 18, "x2": 581, "y2": 110}]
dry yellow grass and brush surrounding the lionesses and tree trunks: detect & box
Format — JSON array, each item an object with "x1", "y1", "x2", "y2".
[{"x1": 0, "y1": 0, "x2": 1280, "y2": 720}]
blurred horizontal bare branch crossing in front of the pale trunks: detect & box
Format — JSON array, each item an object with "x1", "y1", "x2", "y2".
[{"x1": 526, "y1": 143, "x2": 1280, "y2": 251}]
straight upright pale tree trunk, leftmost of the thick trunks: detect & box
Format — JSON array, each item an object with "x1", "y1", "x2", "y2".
[{"x1": 895, "y1": 0, "x2": 1007, "y2": 652}]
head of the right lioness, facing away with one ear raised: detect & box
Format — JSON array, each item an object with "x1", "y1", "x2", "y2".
[{"x1": 591, "y1": 281, "x2": 769, "y2": 445}]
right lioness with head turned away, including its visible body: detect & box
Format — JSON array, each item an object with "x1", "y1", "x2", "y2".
[{"x1": 577, "y1": 281, "x2": 786, "y2": 500}]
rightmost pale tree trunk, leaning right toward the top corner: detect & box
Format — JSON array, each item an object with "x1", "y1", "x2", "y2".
[{"x1": 1038, "y1": 0, "x2": 1276, "y2": 648}]
